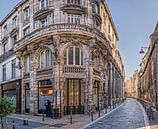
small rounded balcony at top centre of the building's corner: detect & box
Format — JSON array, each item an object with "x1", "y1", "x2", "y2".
[{"x1": 61, "y1": 3, "x2": 87, "y2": 15}]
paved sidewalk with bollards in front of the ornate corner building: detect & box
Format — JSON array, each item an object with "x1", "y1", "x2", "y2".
[{"x1": 10, "y1": 104, "x2": 123, "y2": 129}]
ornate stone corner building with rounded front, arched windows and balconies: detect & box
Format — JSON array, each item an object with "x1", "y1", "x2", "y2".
[{"x1": 0, "y1": 0, "x2": 125, "y2": 115}]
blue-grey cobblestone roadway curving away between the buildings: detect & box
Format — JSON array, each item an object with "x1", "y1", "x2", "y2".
[{"x1": 86, "y1": 99, "x2": 145, "y2": 129}]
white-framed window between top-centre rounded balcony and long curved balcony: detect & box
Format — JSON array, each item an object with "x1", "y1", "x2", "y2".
[{"x1": 68, "y1": 14, "x2": 81, "y2": 24}]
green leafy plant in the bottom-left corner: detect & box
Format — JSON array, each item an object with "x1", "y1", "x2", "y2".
[{"x1": 0, "y1": 97, "x2": 15, "y2": 129}]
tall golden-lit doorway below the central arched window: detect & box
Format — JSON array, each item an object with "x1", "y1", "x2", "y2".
[{"x1": 64, "y1": 79, "x2": 84, "y2": 115}]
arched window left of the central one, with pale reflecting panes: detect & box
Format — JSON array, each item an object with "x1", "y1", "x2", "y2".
[{"x1": 38, "y1": 49, "x2": 52, "y2": 69}]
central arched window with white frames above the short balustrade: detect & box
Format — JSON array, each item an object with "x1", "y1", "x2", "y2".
[{"x1": 64, "y1": 46, "x2": 83, "y2": 65}]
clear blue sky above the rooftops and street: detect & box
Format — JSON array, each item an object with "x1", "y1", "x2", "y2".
[{"x1": 0, "y1": 0, "x2": 158, "y2": 78}]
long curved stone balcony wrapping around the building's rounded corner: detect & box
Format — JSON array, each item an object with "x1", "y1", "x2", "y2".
[{"x1": 15, "y1": 23, "x2": 111, "y2": 51}]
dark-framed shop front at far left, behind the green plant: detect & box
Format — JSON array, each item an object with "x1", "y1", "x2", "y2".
[{"x1": 2, "y1": 80, "x2": 21, "y2": 113}]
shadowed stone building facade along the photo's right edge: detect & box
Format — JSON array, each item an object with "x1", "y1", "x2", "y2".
[{"x1": 138, "y1": 24, "x2": 158, "y2": 109}]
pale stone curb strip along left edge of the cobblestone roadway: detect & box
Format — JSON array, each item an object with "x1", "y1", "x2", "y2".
[{"x1": 79, "y1": 101, "x2": 127, "y2": 129}]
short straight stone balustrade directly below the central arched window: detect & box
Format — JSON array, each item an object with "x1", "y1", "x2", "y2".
[{"x1": 63, "y1": 66, "x2": 85, "y2": 73}]
